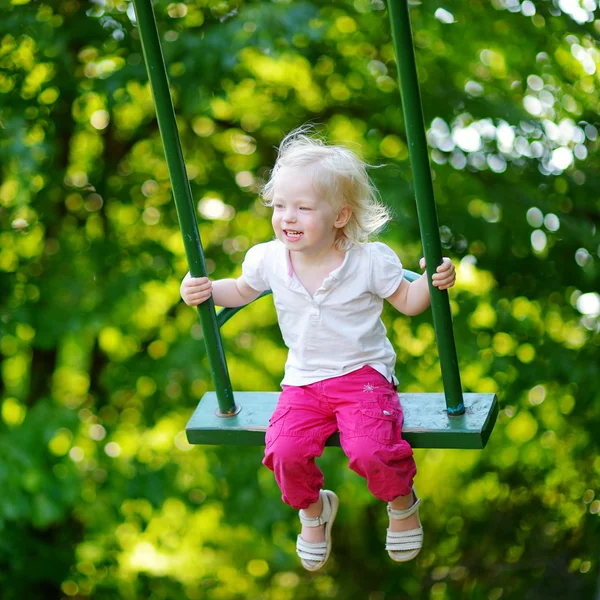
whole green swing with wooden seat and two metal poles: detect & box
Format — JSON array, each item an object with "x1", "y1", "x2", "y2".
[{"x1": 134, "y1": 0, "x2": 498, "y2": 448}]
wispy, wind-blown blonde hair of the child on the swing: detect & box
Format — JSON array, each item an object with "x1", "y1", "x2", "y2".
[{"x1": 262, "y1": 127, "x2": 391, "y2": 250}]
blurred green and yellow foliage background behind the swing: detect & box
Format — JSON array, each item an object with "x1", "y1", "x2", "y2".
[{"x1": 0, "y1": 0, "x2": 600, "y2": 600}]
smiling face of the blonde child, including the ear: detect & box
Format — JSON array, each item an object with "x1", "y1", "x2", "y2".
[{"x1": 271, "y1": 167, "x2": 350, "y2": 254}]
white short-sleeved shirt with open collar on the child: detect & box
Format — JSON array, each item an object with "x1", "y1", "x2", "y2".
[{"x1": 242, "y1": 240, "x2": 402, "y2": 386}]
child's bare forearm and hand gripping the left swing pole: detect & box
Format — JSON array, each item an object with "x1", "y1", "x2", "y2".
[{"x1": 179, "y1": 273, "x2": 261, "y2": 308}]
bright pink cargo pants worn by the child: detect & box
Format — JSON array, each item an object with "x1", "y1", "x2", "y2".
[{"x1": 263, "y1": 367, "x2": 417, "y2": 510}]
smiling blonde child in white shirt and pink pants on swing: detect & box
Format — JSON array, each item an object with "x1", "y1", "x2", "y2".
[{"x1": 181, "y1": 130, "x2": 455, "y2": 571}]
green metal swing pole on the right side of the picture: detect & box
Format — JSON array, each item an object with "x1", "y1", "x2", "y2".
[{"x1": 388, "y1": 0, "x2": 465, "y2": 415}]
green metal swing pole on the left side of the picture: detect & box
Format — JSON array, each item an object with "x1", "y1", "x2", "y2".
[{"x1": 134, "y1": 0, "x2": 239, "y2": 416}]
